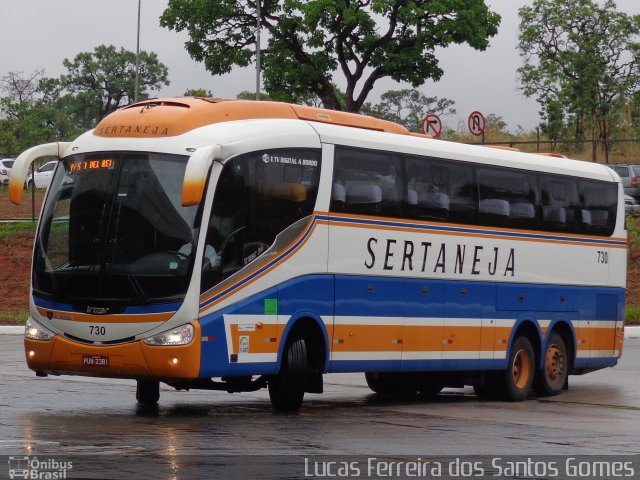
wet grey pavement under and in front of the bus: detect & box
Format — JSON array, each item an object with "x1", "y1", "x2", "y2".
[{"x1": 0, "y1": 335, "x2": 640, "y2": 479}]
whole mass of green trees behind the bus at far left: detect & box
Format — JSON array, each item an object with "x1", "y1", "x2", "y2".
[{"x1": 0, "y1": 45, "x2": 169, "y2": 155}]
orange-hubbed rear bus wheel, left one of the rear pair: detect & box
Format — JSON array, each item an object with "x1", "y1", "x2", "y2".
[{"x1": 503, "y1": 335, "x2": 536, "y2": 402}]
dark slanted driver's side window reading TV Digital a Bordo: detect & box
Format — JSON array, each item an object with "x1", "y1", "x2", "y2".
[{"x1": 201, "y1": 149, "x2": 320, "y2": 292}]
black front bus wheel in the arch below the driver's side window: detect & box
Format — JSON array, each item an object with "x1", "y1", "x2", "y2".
[{"x1": 269, "y1": 337, "x2": 309, "y2": 412}]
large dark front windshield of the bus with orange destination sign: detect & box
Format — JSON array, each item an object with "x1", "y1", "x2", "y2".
[{"x1": 33, "y1": 152, "x2": 198, "y2": 309}]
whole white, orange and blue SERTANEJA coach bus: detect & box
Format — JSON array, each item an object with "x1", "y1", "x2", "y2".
[{"x1": 10, "y1": 98, "x2": 627, "y2": 410}]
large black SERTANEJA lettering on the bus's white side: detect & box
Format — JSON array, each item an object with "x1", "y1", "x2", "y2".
[{"x1": 364, "y1": 237, "x2": 516, "y2": 277}]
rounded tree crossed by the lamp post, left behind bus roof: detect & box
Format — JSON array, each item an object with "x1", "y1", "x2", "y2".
[{"x1": 60, "y1": 45, "x2": 169, "y2": 122}]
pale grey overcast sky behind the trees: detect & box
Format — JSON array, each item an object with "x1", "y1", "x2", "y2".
[{"x1": 0, "y1": 0, "x2": 640, "y2": 132}]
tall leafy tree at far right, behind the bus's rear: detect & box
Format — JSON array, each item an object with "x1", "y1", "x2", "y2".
[{"x1": 518, "y1": 0, "x2": 640, "y2": 155}]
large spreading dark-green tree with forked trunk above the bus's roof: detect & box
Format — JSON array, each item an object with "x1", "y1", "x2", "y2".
[{"x1": 160, "y1": 0, "x2": 500, "y2": 112}]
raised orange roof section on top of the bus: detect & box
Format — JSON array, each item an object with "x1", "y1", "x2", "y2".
[{"x1": 93, "y1": 97, "x2": 409, "y2": 138}]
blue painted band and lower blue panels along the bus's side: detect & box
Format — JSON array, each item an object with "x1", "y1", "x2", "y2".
[{"x1": 200, "y1": 275, "x2": 624, "y2": 377}]
